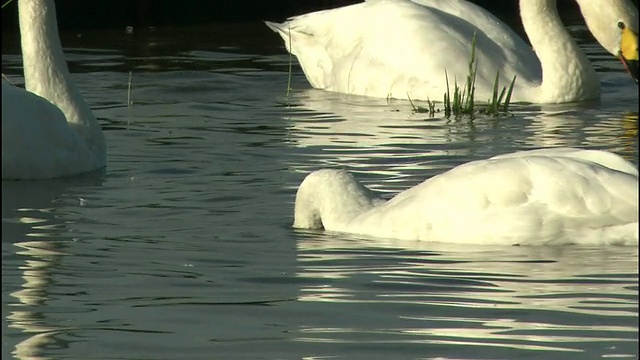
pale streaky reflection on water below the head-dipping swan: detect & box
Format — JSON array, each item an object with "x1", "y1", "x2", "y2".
[{"x1": 298, "y1": 232, "x2": 638, "y2": 359}]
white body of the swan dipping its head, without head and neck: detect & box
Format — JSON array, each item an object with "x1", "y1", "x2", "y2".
[{"x1": 356, "y1": 154, "x2": 638, "y2": 244}]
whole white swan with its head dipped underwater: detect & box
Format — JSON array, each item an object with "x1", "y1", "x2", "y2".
[{"x1": 293, "y1": 148, "x2": 638, "y2": 245}]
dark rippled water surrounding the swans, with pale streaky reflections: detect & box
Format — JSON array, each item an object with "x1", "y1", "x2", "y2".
[{"x1": 2, "y1": 24, "x2": 638, "y2": 360}]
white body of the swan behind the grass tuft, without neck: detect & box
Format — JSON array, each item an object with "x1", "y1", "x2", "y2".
[{"x1": 268, "y1": 0, "x2": 541, "y2": 99}]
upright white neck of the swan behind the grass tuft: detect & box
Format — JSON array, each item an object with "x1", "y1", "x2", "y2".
[{"x1": 520, "y1": 0, "x2": 600, "y2": 102}]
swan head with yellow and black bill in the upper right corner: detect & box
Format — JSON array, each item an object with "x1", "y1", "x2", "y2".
[{"x1": 577, "y1": 0, "x2": 638, "y2": 83}]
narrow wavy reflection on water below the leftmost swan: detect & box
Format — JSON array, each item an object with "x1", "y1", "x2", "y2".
[{"x1": 2, "y1": 173, "x2": 101, "y2": 360}]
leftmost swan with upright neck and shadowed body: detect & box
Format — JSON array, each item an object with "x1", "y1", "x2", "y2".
[{"x1": 2, "y1": 0, "x2": 107, "y2": 179}]
